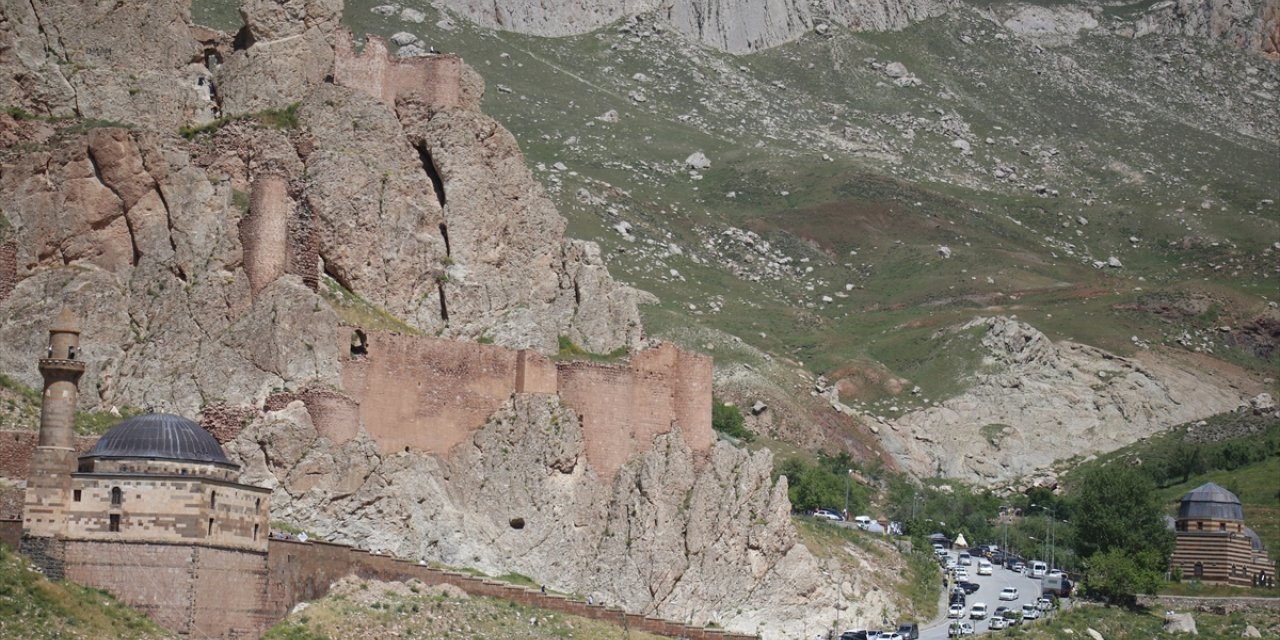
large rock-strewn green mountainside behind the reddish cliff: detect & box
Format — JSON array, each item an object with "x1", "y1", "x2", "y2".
[{"x1": 185, "y1": 0, "x2": 1280, "y2": 468}]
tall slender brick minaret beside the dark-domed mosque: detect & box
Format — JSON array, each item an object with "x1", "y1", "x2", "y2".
[{"x1": 22, "y1": 307, "x2": 84, "y2": 538}]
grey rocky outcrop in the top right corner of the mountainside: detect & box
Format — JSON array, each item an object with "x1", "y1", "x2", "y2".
[{"x1": 1135, "y1": 0, "x2": 1280, "y2": 60}]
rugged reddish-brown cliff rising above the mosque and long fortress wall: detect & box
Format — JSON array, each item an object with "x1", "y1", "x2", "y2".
[{"x1": 0, "y1": 1, "x2": 640, "y2": 413}]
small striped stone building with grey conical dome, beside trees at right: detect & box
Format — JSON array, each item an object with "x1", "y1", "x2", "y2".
[{"x1": 1170, "y1": 483, "x2": 1276, "y2": 586}]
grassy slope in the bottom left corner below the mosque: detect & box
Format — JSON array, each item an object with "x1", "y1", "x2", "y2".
[{"x1": 0, "y1": 544, "x2": 175, "y2": 640}]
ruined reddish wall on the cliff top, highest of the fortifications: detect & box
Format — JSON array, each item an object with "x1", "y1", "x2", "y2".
[{"x1": 333, "y1": 29, "x2": 462, "y2": 109}]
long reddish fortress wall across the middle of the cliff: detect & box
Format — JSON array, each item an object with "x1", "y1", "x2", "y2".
[{"x1": 335, "y1": 328, "x2": 714, "y2": 477}]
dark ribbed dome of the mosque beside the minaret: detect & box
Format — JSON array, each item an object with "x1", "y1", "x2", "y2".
[{"x1": 82, "y1": 413, "x2": 236, "y2": 467}]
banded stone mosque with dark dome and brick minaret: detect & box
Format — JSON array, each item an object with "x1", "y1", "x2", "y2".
[{"x1": 20, "y1": 310, "x2": 278, "y2": 639}]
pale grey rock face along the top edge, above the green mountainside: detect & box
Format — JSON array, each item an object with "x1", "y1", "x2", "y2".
[{"x1": 443, "y1": 0, "x2": 948, "y2": 52}]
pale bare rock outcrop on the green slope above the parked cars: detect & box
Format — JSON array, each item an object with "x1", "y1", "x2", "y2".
[{"x1": 881, "y1": 317, "x2": 1244, "y2": 484}]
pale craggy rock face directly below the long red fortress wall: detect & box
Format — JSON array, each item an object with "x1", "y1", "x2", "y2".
[{"x1": 225, "y1": 394, "x2": 895, "y2": 637}]
